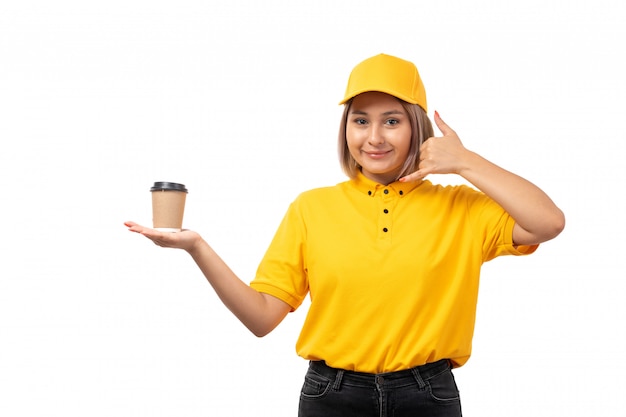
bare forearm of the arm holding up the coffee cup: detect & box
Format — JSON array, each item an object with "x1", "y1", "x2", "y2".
[{"x1": 188, "y1": 239, "x2": 288, "y2": 337}]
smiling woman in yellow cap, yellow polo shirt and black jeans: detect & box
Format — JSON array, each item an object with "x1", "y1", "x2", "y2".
[{"x1": 126, "y1": 54, "x2": 565, "y2": 417}]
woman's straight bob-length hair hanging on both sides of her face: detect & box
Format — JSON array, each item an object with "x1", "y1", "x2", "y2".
[{"x1": 338, "y1": 98, "x2": 434, "y2": 180}]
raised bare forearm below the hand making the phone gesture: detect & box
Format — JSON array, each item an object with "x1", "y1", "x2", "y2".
[{"x1": 459, "y1": 151, "x2": 565, "y2": 244}]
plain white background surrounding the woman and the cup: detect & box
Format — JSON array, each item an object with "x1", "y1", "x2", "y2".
[{"x1": 0, "y1": 0, "x2": 626, "y2": 417}]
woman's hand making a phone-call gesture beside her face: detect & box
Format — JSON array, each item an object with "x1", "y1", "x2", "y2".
[{"x1": 400, "y1": 112, "x2": 468, "y2": 182}]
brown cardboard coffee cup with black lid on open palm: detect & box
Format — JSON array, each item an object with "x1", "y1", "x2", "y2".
[{"x1": 150, "y1": 182, "x2": 187, "y2": 232}]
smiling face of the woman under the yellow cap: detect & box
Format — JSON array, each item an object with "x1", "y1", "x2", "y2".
[{"x1": 346, "y1": 91, "x2": 411, "y2": 184}]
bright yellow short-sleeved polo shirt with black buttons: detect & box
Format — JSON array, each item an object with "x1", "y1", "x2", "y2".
[{"x1": 251, "y1": 171, "x2": 537, "y2": 373}]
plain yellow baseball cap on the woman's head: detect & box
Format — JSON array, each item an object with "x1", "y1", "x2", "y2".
[{"x1": 339, "y1": 54, "x2": 428, "y2": 111}]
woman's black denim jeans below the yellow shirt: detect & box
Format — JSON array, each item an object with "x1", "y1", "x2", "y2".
[{"x1": 298, "y1": 359, "x2": 461, "y2": 417}]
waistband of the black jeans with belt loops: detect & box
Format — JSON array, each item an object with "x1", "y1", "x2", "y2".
[{"x1": 309, "y1": 359, "x2": 452, "y2": 389}]
